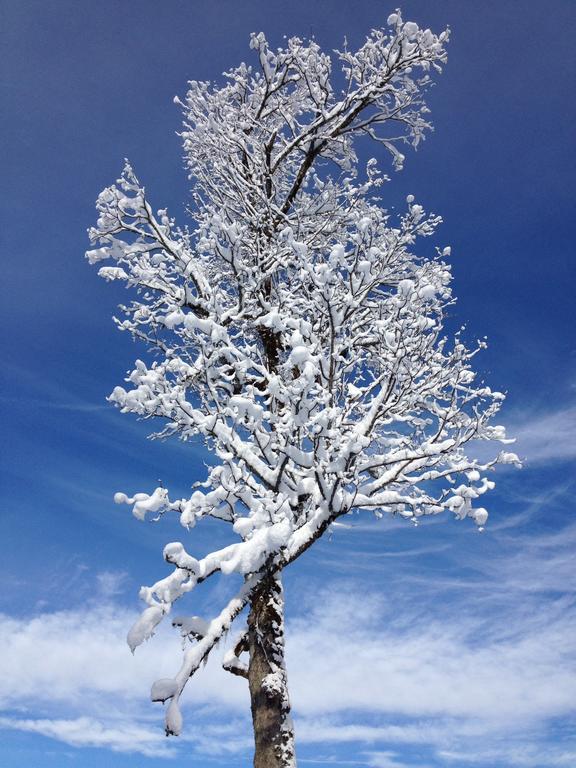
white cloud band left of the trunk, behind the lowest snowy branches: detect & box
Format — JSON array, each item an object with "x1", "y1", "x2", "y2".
[{"x1": 0, "y1": 602, "x2": 246, "y2": 721}]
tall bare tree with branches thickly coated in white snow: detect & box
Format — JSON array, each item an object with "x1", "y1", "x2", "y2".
[{"x1": 87, "y1": 12, "x2": 516, "y2": 768}]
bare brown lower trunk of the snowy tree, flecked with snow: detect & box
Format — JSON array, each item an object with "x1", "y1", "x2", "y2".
[{"x1": 248, "y1": 574, "x2": 296, "y2": 768}]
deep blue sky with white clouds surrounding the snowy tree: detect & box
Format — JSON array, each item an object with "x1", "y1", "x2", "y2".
[{"x1": 0, "y1": 0, "x2": 576, "y2": 768}]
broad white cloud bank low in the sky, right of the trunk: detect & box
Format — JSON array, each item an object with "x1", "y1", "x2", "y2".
[{"x1": 288, "y1": 594, "x2": 576, "y2": 722}]
